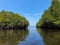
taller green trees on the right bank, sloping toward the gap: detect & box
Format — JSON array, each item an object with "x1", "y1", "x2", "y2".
[{"x1": 36, "y1": 0, "x2": 60, "y2": 28}]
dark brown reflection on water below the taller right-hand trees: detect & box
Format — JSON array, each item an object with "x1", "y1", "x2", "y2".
[{"x1": 38, "y1": 28, "x2": 60, "y2": 45}]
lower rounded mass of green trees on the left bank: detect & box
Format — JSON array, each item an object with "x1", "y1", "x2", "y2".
[{"x1": 0, "y1": 10, "x2": 29, "y2": 28}]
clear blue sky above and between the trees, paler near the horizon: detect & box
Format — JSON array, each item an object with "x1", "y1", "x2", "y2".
[{"x1": 0, "y1": 0, "x2": 51, "y2": 26}]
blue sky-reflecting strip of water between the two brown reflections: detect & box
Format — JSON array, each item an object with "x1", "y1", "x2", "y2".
[{"x1": 18, "y1": 26, "x2": 44, "y2": 45}]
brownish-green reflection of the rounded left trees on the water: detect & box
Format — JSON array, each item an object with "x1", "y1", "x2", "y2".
[{"x1": 0, "y1": 29, "x2": 28, "y2": 45}]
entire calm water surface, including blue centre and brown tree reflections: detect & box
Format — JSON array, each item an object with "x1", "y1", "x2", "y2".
[{"x1": 0, "y1": 27, "x2": 60, "y2": 45}]
